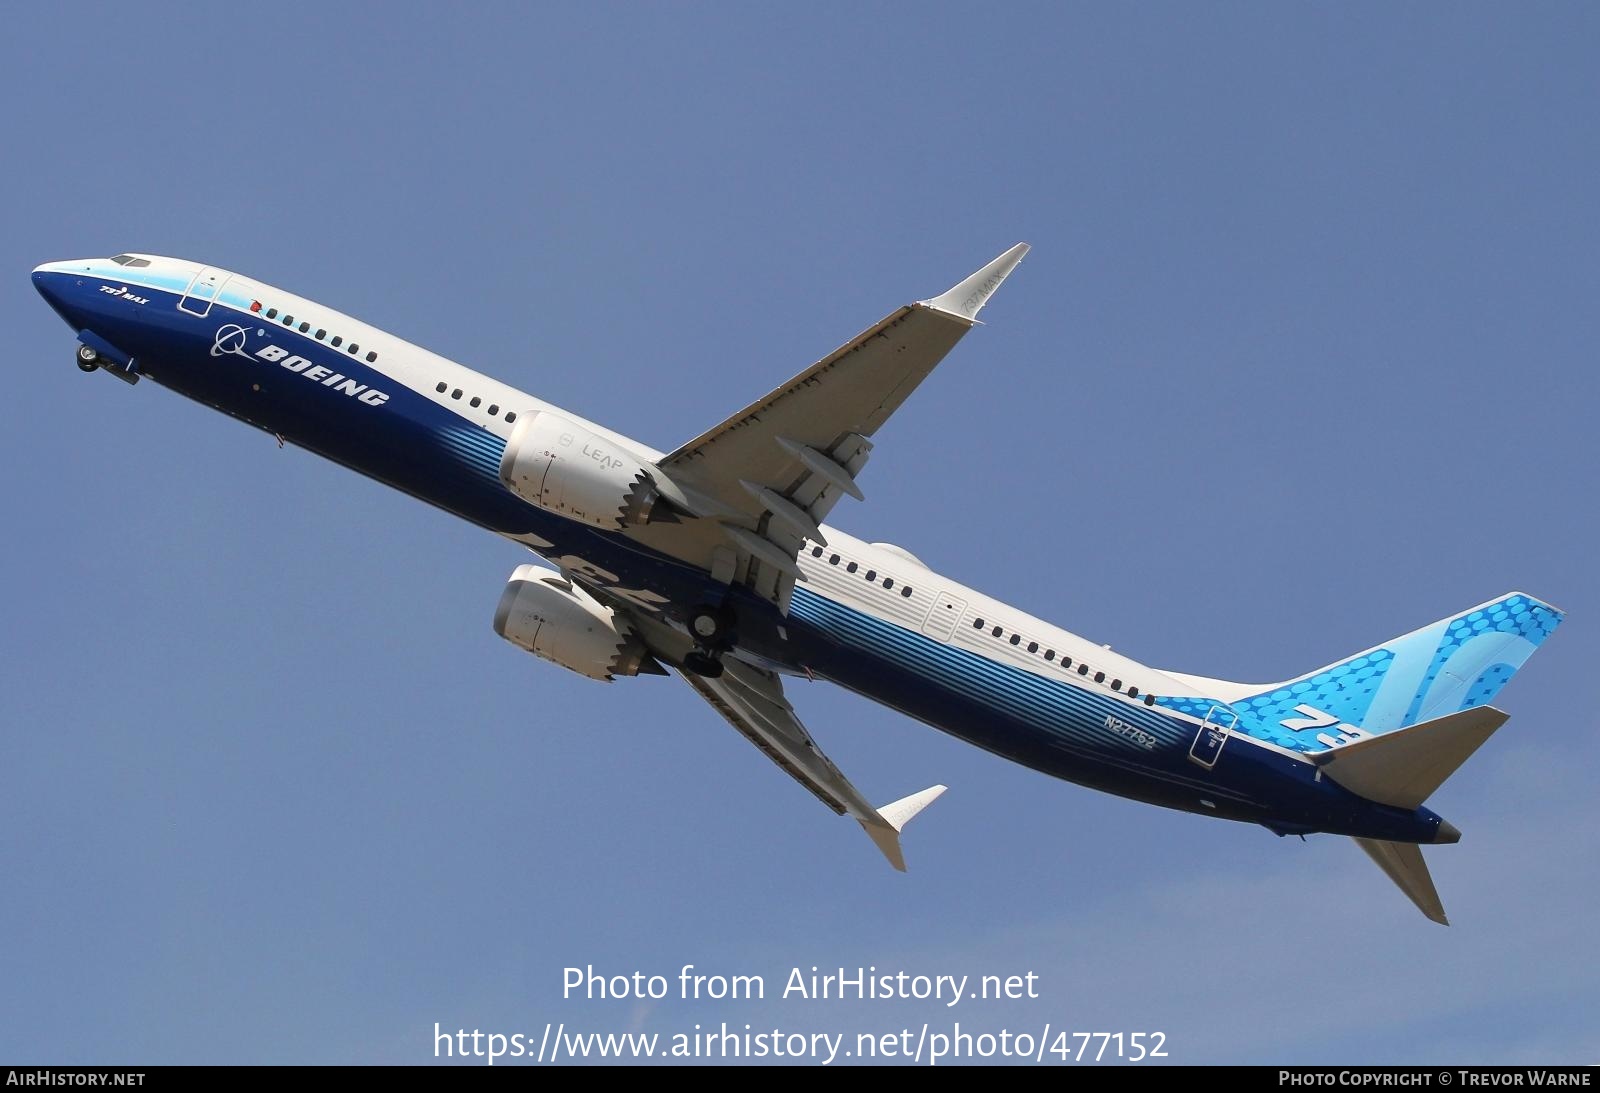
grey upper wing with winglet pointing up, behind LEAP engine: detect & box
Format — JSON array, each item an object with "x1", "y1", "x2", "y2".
[{"x1": 629, "y1": 243, "x2": 1027, "y2": 611}]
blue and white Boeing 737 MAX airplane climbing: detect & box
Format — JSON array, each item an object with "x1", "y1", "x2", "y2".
[{"x1": 34, "y1": 243, "x2": 1562, "y2": 923}]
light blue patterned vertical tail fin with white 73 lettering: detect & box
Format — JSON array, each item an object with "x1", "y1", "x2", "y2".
[{"x1": 1179, "y1": 592, "x2": 1562, "y2": 752}]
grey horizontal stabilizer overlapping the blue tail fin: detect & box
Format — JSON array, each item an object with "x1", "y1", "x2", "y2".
[{"x1": 1317, "y1": 706, "x2": 1506, "y2": 806}]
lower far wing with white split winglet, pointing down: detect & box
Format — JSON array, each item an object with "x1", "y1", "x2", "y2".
[{"x1": 680, "y1": 656, "x2": 946, "y2": 872}]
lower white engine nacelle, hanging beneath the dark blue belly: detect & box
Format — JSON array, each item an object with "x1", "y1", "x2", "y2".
[{"x1": 494, "y1": 565, "x2": 661, "y2": 680}]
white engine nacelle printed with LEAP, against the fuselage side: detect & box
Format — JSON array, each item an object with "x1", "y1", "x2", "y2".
[{"x1": 501, "y1": 410, "x2": 661, "y2": 531}]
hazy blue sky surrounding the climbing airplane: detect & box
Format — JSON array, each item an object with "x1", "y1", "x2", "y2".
[{"x1": 0, "y1": 3, "x2": 1600, "y2": 1063}]
